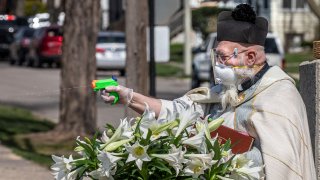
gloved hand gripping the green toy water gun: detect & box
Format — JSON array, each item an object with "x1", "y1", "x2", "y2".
[{"x1": 101, "y1": 85, "x2": 133, "y2": 105}]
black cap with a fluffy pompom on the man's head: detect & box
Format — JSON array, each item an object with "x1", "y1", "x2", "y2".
[{"x1": 217, "y1": 4, "x2": 268, "y2": 46}]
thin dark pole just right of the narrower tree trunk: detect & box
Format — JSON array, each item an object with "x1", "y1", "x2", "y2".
[{"x1": 148, "y1": 0, "x2": 156, "y2": 97}]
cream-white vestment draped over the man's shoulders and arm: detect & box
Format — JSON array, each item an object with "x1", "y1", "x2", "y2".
[{"x1": 159, "y1": 66, "x2": 316, "y2": 180}]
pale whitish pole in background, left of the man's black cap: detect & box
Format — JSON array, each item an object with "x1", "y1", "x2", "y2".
[{"x1": 184, "y1": 0, "x2": 191, "y2": 75}]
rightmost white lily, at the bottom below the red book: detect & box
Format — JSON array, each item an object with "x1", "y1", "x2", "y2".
[{"x1": 230, "y1": 154, "x2": 263, "y2": 179}]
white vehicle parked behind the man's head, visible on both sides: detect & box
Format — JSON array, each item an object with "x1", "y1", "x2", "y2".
[{"x1": 191, "y1": 33, "x2": 285, "y2": 88}]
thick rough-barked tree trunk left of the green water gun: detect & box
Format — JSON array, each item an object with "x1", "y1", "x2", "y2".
[{"x1": 55, "y1": 0, "x2": 100, "y2": 135}]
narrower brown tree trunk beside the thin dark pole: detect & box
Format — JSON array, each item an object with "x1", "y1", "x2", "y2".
[{"x1": 126, "y1": 0, "x2": 149, "y2": 117}]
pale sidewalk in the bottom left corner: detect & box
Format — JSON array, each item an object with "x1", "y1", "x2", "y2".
[{"x1": 0, "y1": 144, "x2": 53, "y2": 180}]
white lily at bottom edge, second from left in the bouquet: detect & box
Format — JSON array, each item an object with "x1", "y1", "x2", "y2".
[{"x1": 90, "y1": 152, "x2": 121, "y2": 179}]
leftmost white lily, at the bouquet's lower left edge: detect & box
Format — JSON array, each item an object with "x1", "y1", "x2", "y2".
[{"x1": 51, "y1": 155, "x2": 76, "y2": 180}]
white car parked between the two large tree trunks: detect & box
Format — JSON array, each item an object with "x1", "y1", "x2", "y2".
[{"x1": 96, "y1": 31, "x2": 126, "y2": 76}]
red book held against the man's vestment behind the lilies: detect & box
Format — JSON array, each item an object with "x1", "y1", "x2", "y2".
[{"x1": 211, "y1": 125, "x2": 254, "y2": 154}]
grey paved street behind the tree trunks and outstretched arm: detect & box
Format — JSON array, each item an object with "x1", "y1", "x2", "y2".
[{"x1": 0, "y1": 62, "x2": 190, "y2": 127}]
